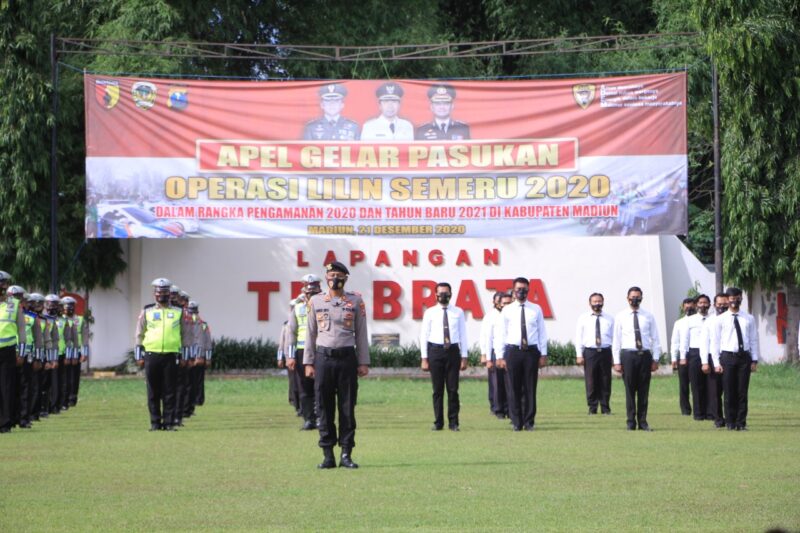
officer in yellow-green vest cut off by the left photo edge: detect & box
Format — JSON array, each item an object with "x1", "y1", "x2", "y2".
[{"x1": 0, "y1": 270, "x2": 27, "y2": 433}]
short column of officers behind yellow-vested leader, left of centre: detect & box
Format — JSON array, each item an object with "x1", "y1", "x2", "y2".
[{"x1": 134, "y1": 278, "x2": 213, "y2": 431}]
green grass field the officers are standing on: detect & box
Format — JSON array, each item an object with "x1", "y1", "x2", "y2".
[{"x1": 0, "y1": 367, "x2": 800, "y2": 533}]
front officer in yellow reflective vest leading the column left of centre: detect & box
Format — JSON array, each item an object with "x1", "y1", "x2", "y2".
[{"x1": 135, "y1": 278, "x2": 190, "y2": 431}]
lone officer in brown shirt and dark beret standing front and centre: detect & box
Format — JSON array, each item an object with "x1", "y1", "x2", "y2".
[{"x1": 303, "y1": 261, "x2": 370, "y2": 468}]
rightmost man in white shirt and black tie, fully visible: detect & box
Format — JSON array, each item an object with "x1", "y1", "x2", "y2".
[{"x1": 711, "y1": 287, "x2": 759, "y2": 431}]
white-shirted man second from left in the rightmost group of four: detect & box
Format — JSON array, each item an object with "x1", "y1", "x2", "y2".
[{"x1": 675, "y1": 294, "x2": 714, "y2": 420}]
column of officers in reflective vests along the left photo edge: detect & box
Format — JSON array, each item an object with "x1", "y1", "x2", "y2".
[{"x1": 0, "y1": 271, "x2": 90, "y2": 433}]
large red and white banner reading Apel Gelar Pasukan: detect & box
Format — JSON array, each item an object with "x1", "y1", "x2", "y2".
[{"x1": 84, "y1": 73, "x2": 687, "y2": 238}]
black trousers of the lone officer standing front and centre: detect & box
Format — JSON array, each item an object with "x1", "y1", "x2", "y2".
[{"x1": 314, "y1": 348, "x2": 358, "y2": 451}]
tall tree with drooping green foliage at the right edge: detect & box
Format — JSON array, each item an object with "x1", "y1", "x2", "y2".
[{"x1": 694, "y1": 0, "x2": 800, "y2": 361}]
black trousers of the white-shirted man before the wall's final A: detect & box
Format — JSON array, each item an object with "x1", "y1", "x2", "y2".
[{"x1": 504, "y1": 344, "x2": 541, "y2": 428}]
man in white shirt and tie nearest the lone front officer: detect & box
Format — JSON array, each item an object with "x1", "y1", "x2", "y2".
[{"x1": 419, "y1": 283, "x2": 468, "y2": 431}]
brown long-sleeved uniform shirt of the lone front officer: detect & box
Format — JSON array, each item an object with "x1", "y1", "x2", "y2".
[{"x1": 303, "y1": 292, "x2": 369, "y2": 365}]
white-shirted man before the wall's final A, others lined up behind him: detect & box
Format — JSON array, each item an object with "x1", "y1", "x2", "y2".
[{"x1": 494, "y1": 278, "x2": 547, "y2": 431}]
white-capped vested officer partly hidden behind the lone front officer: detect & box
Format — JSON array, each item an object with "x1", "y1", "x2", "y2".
[{"x1": 286, "y1": 274, "x2": 322, "y2": 431}]
